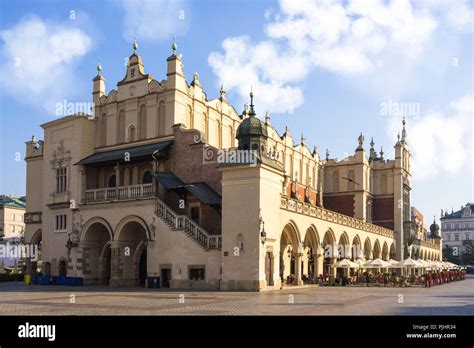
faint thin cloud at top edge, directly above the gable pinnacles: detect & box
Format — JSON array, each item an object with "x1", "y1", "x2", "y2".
[{"x1": 121, "y1": 0, "x2": 190, "y2": 41}]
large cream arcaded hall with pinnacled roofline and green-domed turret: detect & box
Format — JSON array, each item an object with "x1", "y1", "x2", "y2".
[{"x1": 25, "y1": 43, "x2": 442, "y2": 291}]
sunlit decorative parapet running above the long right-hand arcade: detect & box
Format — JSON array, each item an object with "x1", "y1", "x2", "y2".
[{"x1": 280, "y1": 195, "x2": 395, "y2": 238}]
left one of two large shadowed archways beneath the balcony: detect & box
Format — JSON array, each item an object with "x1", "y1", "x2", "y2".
[{"x1": 79, "y1": 222, "x2": 111, "y2": 285}]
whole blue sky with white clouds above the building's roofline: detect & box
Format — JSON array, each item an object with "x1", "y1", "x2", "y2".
[{"x1": 0, "y1": 0, "x2": 474, "y2": 226}]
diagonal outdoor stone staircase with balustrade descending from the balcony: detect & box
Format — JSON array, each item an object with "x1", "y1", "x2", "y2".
[{"x1": 155, "y1": 197, "x2": 222, "y2": 250}]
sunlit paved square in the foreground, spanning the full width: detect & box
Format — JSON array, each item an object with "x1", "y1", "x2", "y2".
[{"x1": 0, "y1": 275, "x2": 474, "y2": 315}]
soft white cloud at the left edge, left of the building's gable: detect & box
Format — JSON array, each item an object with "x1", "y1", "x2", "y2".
[{"x1": 0, "y1": 16, "x2": 92, "y2": 111}]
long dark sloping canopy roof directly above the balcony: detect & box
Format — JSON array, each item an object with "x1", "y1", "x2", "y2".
[{"x1": 75, "y1": 141, "x2": 173, "y2": 165}]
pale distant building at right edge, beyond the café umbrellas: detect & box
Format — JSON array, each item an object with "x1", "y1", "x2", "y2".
[{"x1": 441, "y1": 203, "x2": 474, "y2": 256}]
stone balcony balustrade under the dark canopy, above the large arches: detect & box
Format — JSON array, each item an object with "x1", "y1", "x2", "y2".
[{"x1": 84, "y1": 183, "x2": 154, "y2": 203}]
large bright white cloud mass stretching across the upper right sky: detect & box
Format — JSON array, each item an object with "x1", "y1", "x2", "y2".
[{"x1": 208, "y1": 0, "x2": 462, "y2": 112}]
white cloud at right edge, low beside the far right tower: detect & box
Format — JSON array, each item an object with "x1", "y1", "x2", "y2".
[{"x1": 387, "y1": 93, "x2": 474, "y2": 181}]
